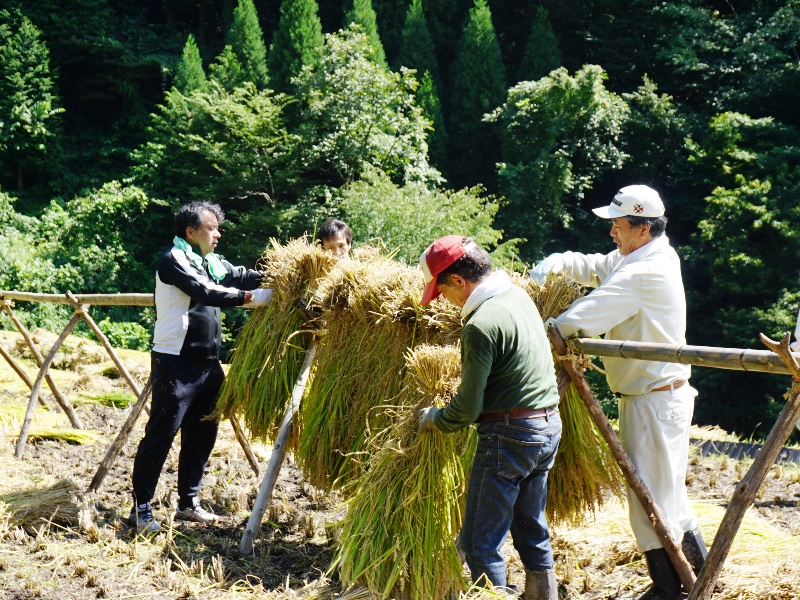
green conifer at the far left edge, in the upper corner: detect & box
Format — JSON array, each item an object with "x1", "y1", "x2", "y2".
[{"x1": 0, "y1": 10, "x2": 63, "y2": 191}]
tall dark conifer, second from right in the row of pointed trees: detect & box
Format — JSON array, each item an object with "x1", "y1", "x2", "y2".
[{"x1": 448, "y1": 0, "x2": 506, "y2": 190}]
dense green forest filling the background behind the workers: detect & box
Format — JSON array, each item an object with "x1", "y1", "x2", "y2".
[{"x1": 0, "y1": 0, "x2": 800, "y2": 437}]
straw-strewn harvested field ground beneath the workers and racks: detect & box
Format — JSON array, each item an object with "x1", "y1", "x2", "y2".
[{"x1": 0, "y1": 331, "x2": 800, "y2": 600}]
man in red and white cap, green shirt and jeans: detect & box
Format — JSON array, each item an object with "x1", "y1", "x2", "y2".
[{"x1": 419, "y1": 235, "x2": 561, "y2": 600}]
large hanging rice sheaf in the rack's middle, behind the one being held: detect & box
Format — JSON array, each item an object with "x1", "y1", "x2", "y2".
[{"x1": 297, "y1": 253, "x2": 440, "y2": 490}]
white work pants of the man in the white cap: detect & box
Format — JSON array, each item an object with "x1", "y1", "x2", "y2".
[{"x1": 619, "y1": 384, "x2": 697, "y2": 552}]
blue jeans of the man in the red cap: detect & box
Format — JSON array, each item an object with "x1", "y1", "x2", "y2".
[{"x1": 459, "y1": 412, "x2": 561, "y2": 586}]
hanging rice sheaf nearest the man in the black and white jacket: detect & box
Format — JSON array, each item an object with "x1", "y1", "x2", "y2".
[{"x1": 215, "y1": 238, "x2": 338, "y2": 439}]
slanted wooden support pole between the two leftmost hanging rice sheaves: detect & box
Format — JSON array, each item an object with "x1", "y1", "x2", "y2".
[{"x1": 239, "y1": 341, "x2": 317, "y2": 554}]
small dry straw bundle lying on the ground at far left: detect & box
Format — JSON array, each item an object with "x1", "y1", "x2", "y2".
[{"x1": 0, "y1": 479, "x2": 78, "y2": 527}]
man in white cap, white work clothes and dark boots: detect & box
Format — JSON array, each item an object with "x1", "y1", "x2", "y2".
[{"x1": 531, "y1": 185, "x2": 707, "y2": 600}]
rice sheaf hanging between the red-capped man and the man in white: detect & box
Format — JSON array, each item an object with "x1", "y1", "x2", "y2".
[{"x1": 517, "y1": 275, "x2": 624, "y2": 525}]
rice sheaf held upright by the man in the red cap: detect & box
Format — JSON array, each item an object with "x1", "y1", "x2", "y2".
[{"x1": 331, "y1": 345, "x2": 476, "y2": 600}]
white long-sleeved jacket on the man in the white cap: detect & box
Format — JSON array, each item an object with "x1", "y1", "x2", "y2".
[{"x1": 552, "y1": 235, "x2": 691, "y2": 396}]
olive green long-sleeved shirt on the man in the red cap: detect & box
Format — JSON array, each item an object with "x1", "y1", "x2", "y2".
[{"x1": 434, "y1": 285, "x2": 559, "y2": 432}]
